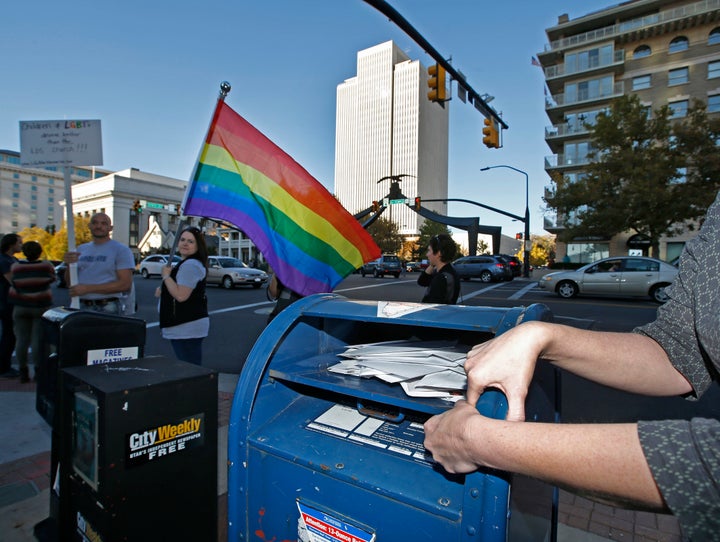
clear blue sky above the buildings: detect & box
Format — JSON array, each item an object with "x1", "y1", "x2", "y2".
[{"x1": 0, "y1": 0, "x2": 614, "y2": 236}]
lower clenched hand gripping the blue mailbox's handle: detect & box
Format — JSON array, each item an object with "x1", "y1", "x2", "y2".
[{"x1": 424, "y1": 401, "x2": 485, "y2": 473}]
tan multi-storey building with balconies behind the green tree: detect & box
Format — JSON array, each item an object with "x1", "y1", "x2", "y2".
[{"x1": 537, "y1": 0, "x2": 720, "y2": 262}]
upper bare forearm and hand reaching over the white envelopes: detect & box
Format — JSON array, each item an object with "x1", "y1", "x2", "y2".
[{"x1": 465, "y1": 322, "x2": 692, "y2": 421}]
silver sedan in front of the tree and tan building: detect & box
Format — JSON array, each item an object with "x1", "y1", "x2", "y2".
[{"x1": 538, "y1": 256, "x2": 678, "y2": 303}]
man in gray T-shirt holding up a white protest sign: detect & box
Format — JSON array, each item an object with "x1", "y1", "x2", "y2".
[{"x1": 63, "y1": 213, "x2": 135, "y2": 315}]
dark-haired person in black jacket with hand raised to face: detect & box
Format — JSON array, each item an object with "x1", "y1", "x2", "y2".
[{"x1": 418, "y1": 233, "x2": 460, "y2": 305}]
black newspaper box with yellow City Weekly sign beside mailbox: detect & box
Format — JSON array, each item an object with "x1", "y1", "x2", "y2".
[{"x1": 59, "y1": 356, "x2": 218, "y2": 542}]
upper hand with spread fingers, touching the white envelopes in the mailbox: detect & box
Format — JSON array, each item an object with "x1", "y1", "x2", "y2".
[{"x1": 465, "y1": 322, "x2": 544, "y2": 421}]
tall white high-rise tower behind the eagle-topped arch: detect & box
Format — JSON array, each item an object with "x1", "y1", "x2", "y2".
[{"x1": 335, "y1": 41, "x2": 449, "y2": 236}]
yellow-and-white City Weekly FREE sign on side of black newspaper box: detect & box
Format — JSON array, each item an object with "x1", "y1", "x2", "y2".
[{"x1": 126, "y1": 414, "x2": 205, "y2": 466}]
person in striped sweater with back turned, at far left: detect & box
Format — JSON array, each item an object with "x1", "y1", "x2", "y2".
[{"x1": 9, "y1": 241, "x2": 55, "y2": 383}]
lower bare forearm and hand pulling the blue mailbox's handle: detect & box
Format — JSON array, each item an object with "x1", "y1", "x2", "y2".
[{"x1": 425, "y1": 401, "x2": 667, "y2": 511}]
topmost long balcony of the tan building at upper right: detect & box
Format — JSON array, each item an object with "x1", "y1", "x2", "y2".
[{"x1": 545, "y1": 0, "x2": 720, "y2": 53}]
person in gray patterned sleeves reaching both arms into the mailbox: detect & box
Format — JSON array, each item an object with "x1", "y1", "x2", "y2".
[{"x1": 425, "y1": 195, "x2": 720, "y2": 540}]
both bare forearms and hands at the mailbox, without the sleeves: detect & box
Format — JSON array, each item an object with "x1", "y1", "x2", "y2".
[{"x1": 425, "y1": 322, "x2": 691, "y2": 510}]
